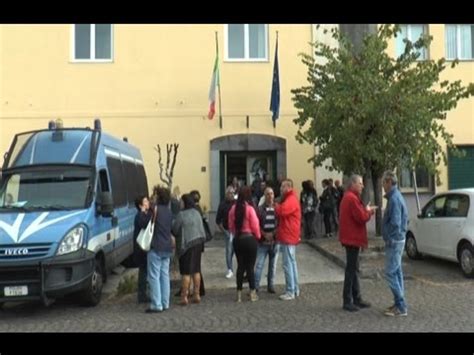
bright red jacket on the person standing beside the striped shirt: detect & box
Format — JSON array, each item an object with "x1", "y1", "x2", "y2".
[{"x1": 275, "y1": 190, "x2": 301, "y2": 245}]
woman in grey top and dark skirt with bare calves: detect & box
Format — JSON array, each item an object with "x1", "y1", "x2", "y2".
[{"x1": 173, "y1": 194, "x2": 206, "y2": 306}]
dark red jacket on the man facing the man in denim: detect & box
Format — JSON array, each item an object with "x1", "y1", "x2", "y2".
[{"x1": 339, "y1": 190, "x2": 371, "y2": 248}]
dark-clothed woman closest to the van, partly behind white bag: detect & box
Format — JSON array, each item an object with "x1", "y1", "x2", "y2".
[{"x1": 133, "y1": 196, "x2": 153, "y2": 303}]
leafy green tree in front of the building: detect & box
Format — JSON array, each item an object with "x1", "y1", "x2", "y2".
[{"x1": 291, "y1": 25, "x2": 474, "y2": 235}]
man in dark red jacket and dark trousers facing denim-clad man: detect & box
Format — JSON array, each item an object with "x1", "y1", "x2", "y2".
[{"x1": 339, "y1": 174, "x2": 377, "y2": 312}]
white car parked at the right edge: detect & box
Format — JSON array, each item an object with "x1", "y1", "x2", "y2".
[{"x1": 405, "y1": 188, "x2": 474, "y2": 277}]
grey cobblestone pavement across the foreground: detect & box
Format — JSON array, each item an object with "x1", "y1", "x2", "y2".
[{"x1": 0, "y1": 270, "x2": 474, "y2": 332}]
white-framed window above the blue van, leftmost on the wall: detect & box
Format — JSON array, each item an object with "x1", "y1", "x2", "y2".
[{"x1": 72, "y1": 24, "x2": 112, "y2": 62}]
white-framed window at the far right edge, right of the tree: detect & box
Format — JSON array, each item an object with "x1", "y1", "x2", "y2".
[{"x1": 444, "y1": 25, "x2": 474, "y2": 59}]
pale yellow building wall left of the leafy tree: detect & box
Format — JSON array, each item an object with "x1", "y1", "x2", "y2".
[{"x1": 0, "y1": 24, "x2": 314, "y2": 214}]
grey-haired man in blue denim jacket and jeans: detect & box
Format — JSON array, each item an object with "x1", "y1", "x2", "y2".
[{"x1": 382, "y1": 170, "x2": 408, "y2": 317}]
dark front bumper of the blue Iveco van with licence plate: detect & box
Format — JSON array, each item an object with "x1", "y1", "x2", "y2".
[{"x1": 0, "y1": 249, "x2": 95, "y2": 303}]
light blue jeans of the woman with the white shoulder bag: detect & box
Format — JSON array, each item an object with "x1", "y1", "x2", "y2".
[{"x1": 148, "y1": 249, "x2": 172, "y2": 310}]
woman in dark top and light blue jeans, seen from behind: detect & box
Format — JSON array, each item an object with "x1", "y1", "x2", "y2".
[{"x1": 146, "y1": 187, "x2": 174, "y2": 313}]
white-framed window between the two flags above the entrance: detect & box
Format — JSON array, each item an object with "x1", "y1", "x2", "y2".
[{"x1": 225, "y1": 24, "x2": 268, "y2": 61}]
